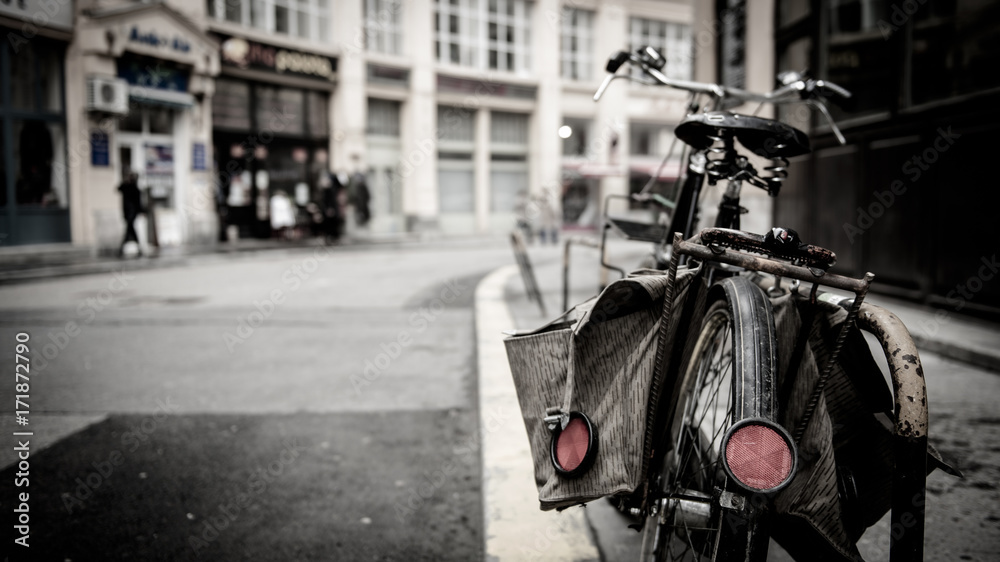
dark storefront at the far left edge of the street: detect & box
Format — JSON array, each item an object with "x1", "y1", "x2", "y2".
[{"x1": 0, "y1": 0, "x2": 73, "y2": 246}]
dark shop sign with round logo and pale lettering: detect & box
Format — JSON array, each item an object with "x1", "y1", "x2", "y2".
[{"x1": 221, "y1": 37, "x2": 337, "y2": 82}]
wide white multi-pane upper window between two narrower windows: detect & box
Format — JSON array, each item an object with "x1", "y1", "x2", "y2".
[{"x1": 434, "y1": 0, "x2": 531, "y2": 72}]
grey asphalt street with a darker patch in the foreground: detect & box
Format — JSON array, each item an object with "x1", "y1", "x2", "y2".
[{"x1": 0, "y1": 240, "x2": 1000, "y2": 561}]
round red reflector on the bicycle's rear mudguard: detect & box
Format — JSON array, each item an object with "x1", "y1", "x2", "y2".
[{"x1": 726, "y1": 424, "x2": 792, "y2": 490}]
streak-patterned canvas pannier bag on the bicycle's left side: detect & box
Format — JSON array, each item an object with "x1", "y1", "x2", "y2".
[{"x1": 505, "y1": 267, "x2": 703, "y2": 510}]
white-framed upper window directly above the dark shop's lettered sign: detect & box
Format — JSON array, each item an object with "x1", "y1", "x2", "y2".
[{"x1": 207, "y1": 0, "x2": 330, "y2": 42}]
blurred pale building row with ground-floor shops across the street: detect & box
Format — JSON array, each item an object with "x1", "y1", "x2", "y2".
[{"x1": 0, "y1": 0, "x2": 696, "y2": 250}]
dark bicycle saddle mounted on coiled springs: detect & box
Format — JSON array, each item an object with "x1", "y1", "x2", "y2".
[{"x1": 676, "y1": 111, "x2": 809, "y2": 158}]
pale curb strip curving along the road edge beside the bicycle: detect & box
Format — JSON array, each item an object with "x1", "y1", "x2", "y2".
[{"x1": 476, "y1": 265, "x2": 600, "y2": 562}]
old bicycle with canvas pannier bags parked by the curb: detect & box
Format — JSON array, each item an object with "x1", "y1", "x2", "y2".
[{"x1": 508, "y1": 47, "x2": 950, "y2": 562}]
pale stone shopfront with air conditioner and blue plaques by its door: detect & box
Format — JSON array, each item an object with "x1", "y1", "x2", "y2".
[{"x1": 67, "y1": 0, "x2": 219, "y2": 251}]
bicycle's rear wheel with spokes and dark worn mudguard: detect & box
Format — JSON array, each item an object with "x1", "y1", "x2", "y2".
[{"x1": 641, "y1": 277, "x2": 776, "y2": 562}]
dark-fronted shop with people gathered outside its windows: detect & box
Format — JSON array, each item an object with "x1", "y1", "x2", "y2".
[{"x1": 212, "y1": 35, "x2": 337, "y2": 238}]
